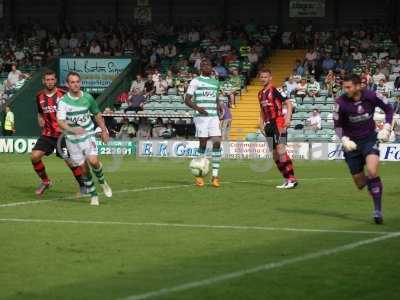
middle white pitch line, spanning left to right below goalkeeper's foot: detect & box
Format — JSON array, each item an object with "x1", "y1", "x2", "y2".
[{"x1": 0, "y1": 218, "x2": 400, "y2": 234}]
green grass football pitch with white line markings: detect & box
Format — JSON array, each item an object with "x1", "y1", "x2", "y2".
[{"x1": 0, "y1": 154, "x2": 400, "y2": 300}]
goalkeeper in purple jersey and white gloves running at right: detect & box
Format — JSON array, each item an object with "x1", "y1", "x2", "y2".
[{"x1": 334, "y1": 74, "x2": 393, "y2": 224}]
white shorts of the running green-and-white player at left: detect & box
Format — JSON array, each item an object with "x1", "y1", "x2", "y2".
[{"x1": 66, "y1": 137, "x2": 97, "y2": 167}]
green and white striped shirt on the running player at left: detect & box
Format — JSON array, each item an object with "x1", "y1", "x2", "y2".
[{"x1": 57, "y1": 92, "x2": 100, "y2": 144}]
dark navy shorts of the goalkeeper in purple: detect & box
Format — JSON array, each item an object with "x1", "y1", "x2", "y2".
[{"x1": 344, "y1": 133, "x2": 380, "y2": 175}]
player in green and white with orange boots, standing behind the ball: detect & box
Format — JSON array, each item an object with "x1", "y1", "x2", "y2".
[{"x1": 185, "y1": 59, "x2": 222, "y2": 187}]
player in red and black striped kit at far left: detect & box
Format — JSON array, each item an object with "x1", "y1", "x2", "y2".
[{"x1": 31, "y1": 70, "x2": 86, "y2": 195}]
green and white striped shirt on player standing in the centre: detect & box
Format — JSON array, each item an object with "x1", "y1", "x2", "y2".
[{"x1": 187, "y1": 76, "x2": 219, "y2": 117}]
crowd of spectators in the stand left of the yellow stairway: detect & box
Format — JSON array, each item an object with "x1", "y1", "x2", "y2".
[{"x1": 0, "y1": 21, "x2": 277, "y2": 135}]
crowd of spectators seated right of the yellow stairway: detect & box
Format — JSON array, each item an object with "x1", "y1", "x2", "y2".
[{"x1": 282, "y1": 25, "x2": 400, "y2": 141}]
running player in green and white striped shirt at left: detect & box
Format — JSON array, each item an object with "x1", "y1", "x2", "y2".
[{"x1": 57, "y1": 72, "x2": 112, "y2": 205}]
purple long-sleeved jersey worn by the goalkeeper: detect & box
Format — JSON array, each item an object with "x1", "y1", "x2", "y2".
[{"x1": 333, "y1": 90, "x2": 393, "y2": 140}]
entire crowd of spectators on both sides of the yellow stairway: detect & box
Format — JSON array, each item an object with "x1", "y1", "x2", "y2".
[{"x1": 0, "y1": 22, "x2": 400, "y2": 142}]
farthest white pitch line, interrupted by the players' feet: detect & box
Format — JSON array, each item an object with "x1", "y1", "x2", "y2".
[{"x1": 0, "y1": 178, "x2": 337, "y2": 208}]
